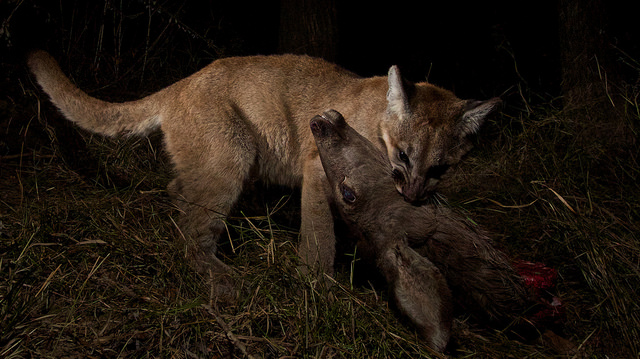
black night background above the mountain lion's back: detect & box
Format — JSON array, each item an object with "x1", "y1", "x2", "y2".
[{"x1": 0, "y1": 0, "x2": 639, "y2": 99}]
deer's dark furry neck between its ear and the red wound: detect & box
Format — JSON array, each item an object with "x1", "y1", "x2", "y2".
[{"x1": 404, "y1": 206, "x2": 533, "y2": 320}]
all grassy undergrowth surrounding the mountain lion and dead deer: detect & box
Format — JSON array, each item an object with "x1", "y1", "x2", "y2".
[{"x1": 0, "y1": 1, "x2": 640, "y2": 358}]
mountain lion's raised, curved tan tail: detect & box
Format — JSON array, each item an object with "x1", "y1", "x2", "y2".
[{"x1": 28, "y1": 51, "x2": 162, "y2": 136}]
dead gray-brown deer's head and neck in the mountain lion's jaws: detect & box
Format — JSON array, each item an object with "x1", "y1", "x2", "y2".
[{"x1": 310, "y1": 111, "x2": 527, "y2": 348}]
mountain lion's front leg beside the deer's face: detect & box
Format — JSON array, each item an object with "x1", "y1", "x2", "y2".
[{"x1": 298, "y1": 155, "x2": 336, "y2": 275}]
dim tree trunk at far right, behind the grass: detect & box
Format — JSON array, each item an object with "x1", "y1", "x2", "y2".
[{"x1": 559, "y1": 0, "x2": 630, "y2": 146}]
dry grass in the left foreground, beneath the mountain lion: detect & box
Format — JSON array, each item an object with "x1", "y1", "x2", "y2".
[{"x1": 0, "y1": 127, "x2": 444, "y2": 358}]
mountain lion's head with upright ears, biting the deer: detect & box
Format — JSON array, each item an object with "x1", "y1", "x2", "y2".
[{"x1": 381, "y1": 66, "x2": 501, "y2": 203}]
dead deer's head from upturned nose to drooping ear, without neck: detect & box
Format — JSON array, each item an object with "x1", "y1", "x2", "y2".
[{"x1": 311, "y1": 111, "x2": 452, "y2": 351}]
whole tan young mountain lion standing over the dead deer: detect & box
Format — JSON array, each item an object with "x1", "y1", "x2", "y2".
[{"x1": 28, "y1": 51, "x2": 495, "y2": 273}]
